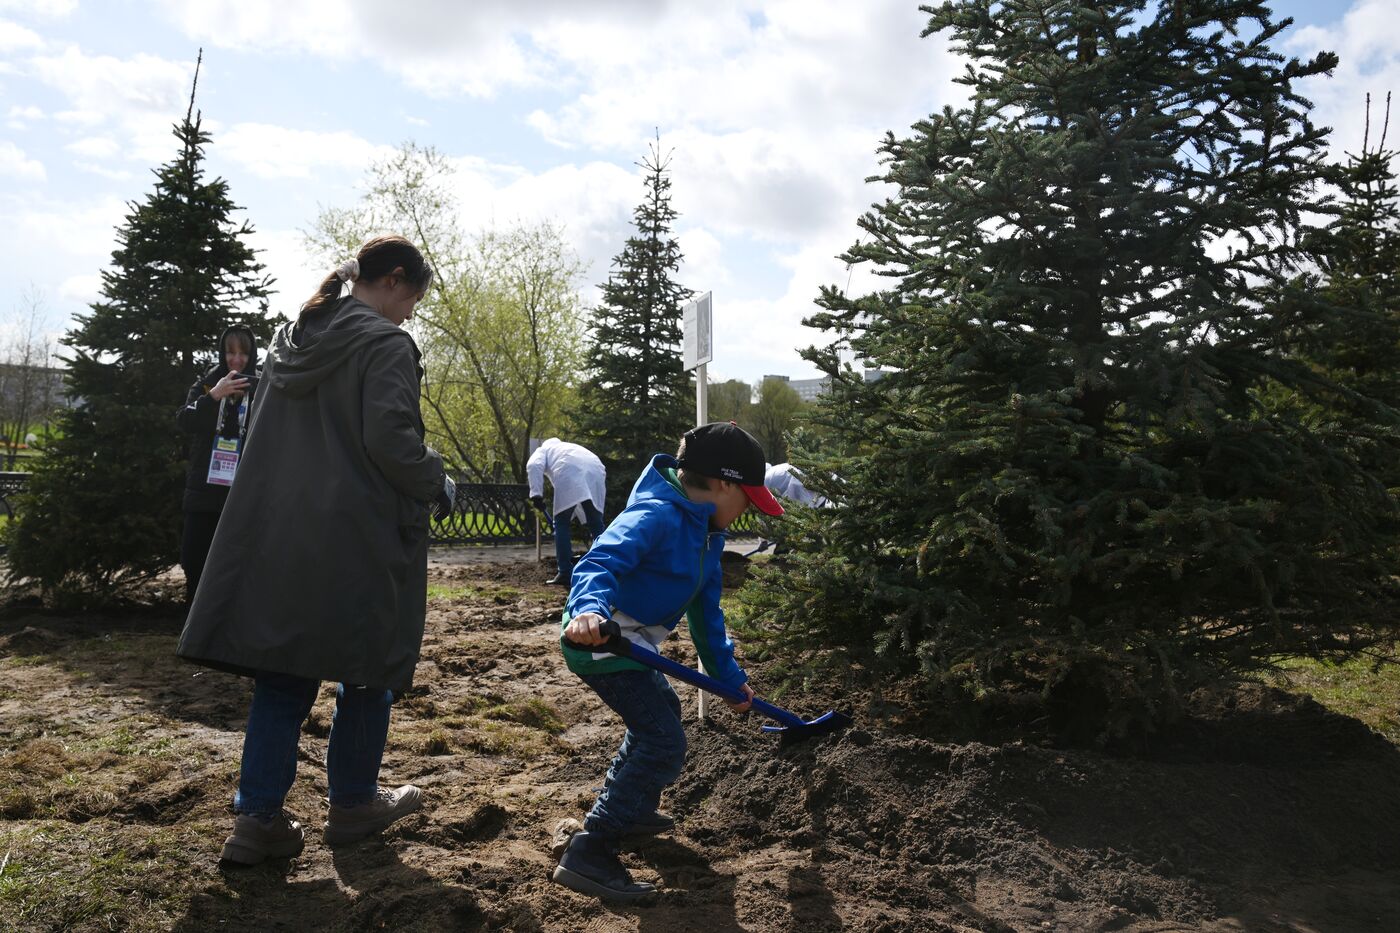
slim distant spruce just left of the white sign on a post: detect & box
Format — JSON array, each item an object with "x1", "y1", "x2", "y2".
[{"x1": 574, "y1": 137, "x2": 694, "y2": 514}]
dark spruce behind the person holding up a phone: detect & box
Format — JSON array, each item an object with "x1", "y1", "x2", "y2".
[{"x1": 8, "y1": 61, "x2": 272, "y2": 591}]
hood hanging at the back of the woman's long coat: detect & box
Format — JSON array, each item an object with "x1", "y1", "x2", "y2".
[{"x1": 267, "y1": 297, "x2": 423, "y2": 395}]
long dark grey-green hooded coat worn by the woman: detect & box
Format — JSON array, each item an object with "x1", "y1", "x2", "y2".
[{"x1": 176, "y1": 298, "x2": 444, "y2": 692}]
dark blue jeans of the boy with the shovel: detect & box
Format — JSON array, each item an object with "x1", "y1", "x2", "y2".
[{"x1": 580, "y1": 671, "x2": 686, "y2": 839}]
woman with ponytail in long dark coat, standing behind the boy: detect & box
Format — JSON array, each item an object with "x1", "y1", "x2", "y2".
[{"x1": 176, "y1": 237, "x2": 449, "y2": 864}]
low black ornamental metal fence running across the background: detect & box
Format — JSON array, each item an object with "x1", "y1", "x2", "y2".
[{"x1": 0, "y1": 472, "x2": 762, "y2": 545}]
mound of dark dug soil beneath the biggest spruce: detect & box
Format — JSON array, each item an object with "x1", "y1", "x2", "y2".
[{"x1": 672, "y1": 688, "x2": 1400, "y2": 930}]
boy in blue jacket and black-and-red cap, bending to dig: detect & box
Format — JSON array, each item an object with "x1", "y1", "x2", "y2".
[{"x1": 553, "y1": 422, "x2": 783, "y2": 902}]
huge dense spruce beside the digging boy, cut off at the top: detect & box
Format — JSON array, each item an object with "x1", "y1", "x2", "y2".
[{"x1": 746, "y1": 0, "x2": 1396, "y2": 734}]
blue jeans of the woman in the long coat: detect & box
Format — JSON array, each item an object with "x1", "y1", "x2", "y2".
[{"x1": 234, "y1": 674, "x2": 393, "y2": 815}]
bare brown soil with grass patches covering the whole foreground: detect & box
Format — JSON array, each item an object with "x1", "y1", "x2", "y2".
[{"x1": 0, "y1": 562, "x2": 1400, "y2": 933}]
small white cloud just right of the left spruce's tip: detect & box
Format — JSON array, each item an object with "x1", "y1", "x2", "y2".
[{"x1": 218, "y1": 123, "x2": 393, "y2": 178}]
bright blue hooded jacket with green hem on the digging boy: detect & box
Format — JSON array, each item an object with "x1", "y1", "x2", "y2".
[{"x1": 560, "y1": 454, "x2": 749, "y2": 686}]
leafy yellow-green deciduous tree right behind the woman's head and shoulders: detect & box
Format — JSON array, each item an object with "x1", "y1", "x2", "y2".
[{"x1": 308, "y1": 144, "x2": 582, "y2": 482}]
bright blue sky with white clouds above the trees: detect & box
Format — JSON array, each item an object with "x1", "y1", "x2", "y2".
[{"x1": 0, "y1": 0, "x2": 1400, "y2": 381}]
